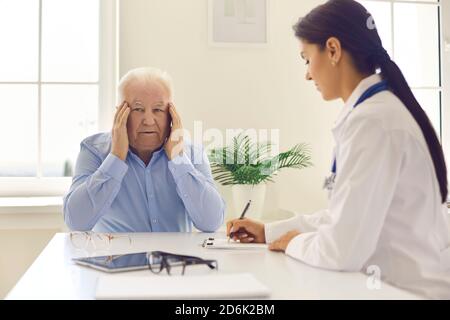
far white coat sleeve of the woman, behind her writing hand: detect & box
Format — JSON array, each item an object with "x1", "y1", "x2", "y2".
[{"x1": 264, "y1": 209, "x2": 330, "y2": 243}]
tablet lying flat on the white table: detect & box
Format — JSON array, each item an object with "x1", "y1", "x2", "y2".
[{"x1": 72, "y1": 252, "x2": 148, "y2": 272}]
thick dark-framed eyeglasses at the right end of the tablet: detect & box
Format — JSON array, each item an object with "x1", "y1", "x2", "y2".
[{"x1": 147, "y1": 251, "x2": 219, "y2": 275}]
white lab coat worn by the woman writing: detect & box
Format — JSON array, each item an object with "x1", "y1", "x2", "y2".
[{"x1": 265, "y1": 75, "x2": 450, "y2": 298}]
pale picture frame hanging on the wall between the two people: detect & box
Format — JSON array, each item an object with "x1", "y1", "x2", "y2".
[{"x1": 208, "y1": 0, "x2": 269, "y2": 47}]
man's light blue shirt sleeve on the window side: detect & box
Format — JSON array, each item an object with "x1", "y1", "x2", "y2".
[{"x1": 63, "y1": 144, "x2": 128, "y2": 231}]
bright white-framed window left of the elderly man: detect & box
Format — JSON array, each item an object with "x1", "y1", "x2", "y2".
[{"x1": 0, "y1": 0, "x2": 116, "y2": 196}]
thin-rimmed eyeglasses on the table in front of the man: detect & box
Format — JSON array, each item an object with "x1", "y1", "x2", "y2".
[{"x1": 70, "y1": 231, "x2": 131, "y2": 249}]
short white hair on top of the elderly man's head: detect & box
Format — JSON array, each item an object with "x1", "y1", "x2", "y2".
[{"x1": 118, "y1": 67, "x2": 173, "y2": 101}]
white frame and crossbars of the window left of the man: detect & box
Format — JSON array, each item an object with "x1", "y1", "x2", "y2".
[{"x1": 0, "y1": 0, "x2": 119, "y2": 197}]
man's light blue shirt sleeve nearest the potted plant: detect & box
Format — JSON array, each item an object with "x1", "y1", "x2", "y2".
[{"x1": 168, "y1": 147, "x2": 225, "y2": 232}]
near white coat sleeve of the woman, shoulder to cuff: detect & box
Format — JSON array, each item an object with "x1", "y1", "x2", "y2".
[{"x1": 286, "y1": 117, "x2": 406, "y2": 271}]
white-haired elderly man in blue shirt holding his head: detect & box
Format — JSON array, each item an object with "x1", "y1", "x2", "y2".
[{"x1": 64, "y1": 68, "x2": 225, "y2": 232}]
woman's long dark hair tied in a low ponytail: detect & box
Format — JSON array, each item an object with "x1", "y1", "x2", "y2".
[{"x1": 293, "y1": 0, "x2": 448, "y2": 203}]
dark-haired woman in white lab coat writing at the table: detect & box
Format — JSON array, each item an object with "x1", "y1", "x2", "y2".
[{"x1": 227, "y1": 0, "x2": 450, "y2": 298}]
